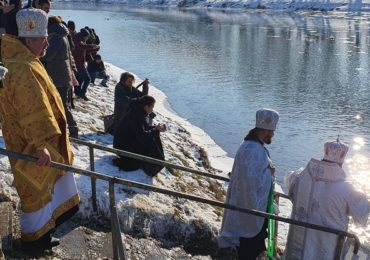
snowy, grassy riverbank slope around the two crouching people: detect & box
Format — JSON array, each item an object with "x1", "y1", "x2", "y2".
[{"x1": 0, "y1": 64, "x2": 290, "y2": 255}]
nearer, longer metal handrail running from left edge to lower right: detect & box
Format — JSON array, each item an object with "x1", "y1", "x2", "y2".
[{"x1": 0, "y1": 148, "x2": 360, "y2": 259}]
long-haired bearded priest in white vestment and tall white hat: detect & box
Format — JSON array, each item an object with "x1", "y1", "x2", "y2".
[{"x1": 218, "y1": 109, "x2": 279, "y2": 260}]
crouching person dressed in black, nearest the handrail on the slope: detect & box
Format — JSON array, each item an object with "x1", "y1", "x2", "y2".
[{"x1": 113, "y1": 96, "x2": 166, "y2": 176}]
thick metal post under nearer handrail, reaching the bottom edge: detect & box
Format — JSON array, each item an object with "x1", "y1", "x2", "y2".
[{"x1": 109, "y1": 179, "x2": 128, "y2": 260}]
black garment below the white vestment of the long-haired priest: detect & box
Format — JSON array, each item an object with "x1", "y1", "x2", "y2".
[{"x1": 236, "y1": 220, "x2": 267, "y2": 260}]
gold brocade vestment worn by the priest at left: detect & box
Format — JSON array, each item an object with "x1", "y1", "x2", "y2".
[{"x1": 0, "y1": 35, "x2": 73, "y2": 212}]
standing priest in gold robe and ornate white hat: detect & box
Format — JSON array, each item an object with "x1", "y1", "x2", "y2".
[{"x1": 0, "y1": 9, "x2": 80, "y2": 251}]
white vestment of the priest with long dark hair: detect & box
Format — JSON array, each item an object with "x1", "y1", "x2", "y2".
[{"x1": 218, "y1": 140, "x2": 272, "y2": 247}]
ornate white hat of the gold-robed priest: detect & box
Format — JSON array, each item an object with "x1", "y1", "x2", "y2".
[{"x1": 16, "y1": 8, "x2": 48, "y2": 38}]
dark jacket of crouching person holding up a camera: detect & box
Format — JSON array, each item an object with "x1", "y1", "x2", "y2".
[{"x1": 114, "y1": 82, "x2": 148, "y2": 124}]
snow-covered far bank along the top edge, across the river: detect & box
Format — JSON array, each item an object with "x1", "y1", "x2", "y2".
[{"x1": 57, "y1": 0, "x2": 370, "y2": 12}]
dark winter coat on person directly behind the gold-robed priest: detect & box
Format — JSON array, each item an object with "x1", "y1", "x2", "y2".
[{"x1": 42, "y1": 24, "x2": 73, "y2": 88}]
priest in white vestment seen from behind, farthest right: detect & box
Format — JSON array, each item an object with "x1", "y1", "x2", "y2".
[{"x1": 285, "y1": 142, "x2": 370, "y2": 260}]
